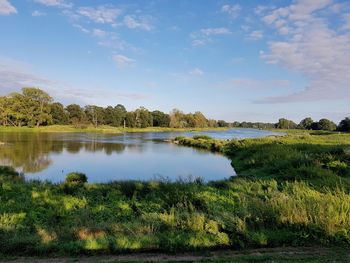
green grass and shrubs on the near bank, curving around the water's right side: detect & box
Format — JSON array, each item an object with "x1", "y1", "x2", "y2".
[{"x1": 0, "y1": 132, "x2": 350, "y2": 262}]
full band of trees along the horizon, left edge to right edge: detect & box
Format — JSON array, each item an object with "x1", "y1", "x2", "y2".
[{"x1": 0, "y1": 88, "x2": 350, "y2": 132}]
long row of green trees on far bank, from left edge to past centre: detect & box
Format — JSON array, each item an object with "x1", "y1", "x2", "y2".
[{"x1": 0, "y1": 88, "x2": 219, "y2": 128}]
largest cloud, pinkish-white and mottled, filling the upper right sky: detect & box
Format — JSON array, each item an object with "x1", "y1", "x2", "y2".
[{"x1": 259, "y1": 0, "x2": 350, "y2": 103}]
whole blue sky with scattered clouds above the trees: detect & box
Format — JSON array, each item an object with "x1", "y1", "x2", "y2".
[{"x1": 0, "y1": 0, "x2": 350, "y2": 122}]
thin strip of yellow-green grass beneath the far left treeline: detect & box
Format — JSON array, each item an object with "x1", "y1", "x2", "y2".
[{"x1": 0, "y1": 125, "x2": 227, "y2": 133}]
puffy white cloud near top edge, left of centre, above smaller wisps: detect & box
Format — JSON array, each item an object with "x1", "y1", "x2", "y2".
[{"x1": 77, "y1": 6, "x2": 121, "y2": 24}]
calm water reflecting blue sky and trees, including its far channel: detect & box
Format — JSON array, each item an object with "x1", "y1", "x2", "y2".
[{"x1": 0, "y1": 129, "x2": 281, "y2": 183}]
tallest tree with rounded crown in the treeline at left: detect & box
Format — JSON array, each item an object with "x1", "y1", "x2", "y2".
[{"x1": 22, "y1": 88, "x2": 52, "y2": 127}]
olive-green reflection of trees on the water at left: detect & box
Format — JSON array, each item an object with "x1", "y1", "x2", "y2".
[{"x1": 0, "y1": 133, "x2": 126, "y2": 173}]
